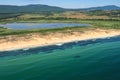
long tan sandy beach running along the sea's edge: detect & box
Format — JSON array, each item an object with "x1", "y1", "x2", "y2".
[{"x1": 0, "y1": 29, "x2": 120, "y2": 51}]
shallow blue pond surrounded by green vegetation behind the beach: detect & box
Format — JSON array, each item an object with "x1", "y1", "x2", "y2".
[{"x1": 2, "y1": 23, "x2": 90, "y2": 29}]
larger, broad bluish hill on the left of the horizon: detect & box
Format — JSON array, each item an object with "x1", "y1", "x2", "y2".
[{"x1": 0, "y1": 4, "x2": 65, "y2": 13}]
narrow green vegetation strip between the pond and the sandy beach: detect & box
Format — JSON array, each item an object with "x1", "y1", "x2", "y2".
[{"x1": 0, "y1": 27, "x2": 88, "y2": 36}]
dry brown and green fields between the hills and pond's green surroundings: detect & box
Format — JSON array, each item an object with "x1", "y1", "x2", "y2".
[{"x1": 0, "y1": 10, "x2": 120, "y2": 21}]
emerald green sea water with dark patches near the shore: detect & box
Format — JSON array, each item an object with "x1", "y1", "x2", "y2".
[{"x1": 0, "y1": 37, "x2": 120, "y2": 80}]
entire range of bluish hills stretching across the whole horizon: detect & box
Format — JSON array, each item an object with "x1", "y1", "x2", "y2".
[{"x1": 0, "y1": 4, "x2": 120, "y2": 13}]
